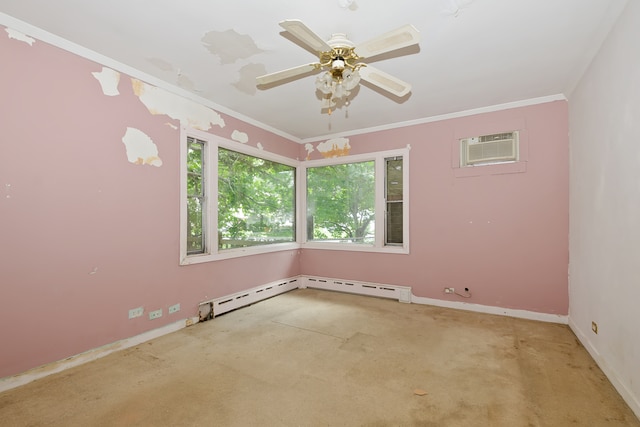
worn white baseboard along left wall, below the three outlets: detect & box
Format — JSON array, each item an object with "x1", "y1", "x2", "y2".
[{"x1": 0, "y1": 317, "x2": 198, "y2": 393}]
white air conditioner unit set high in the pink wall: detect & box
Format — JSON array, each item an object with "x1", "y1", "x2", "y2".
[{"x1": 460, "y1": 132, "x2": 518, "y2": 166}]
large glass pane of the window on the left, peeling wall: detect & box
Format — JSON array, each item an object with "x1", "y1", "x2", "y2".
[{"x1": 218, "y1": 148, "x2": 295, "y2": 249}]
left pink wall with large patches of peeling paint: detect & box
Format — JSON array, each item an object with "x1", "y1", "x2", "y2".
[{"x1": 0, "y1": 28, "x2": 299, "y2": 378}]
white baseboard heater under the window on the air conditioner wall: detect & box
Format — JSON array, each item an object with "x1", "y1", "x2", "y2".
[{"x1": 300, "y1": 276, "x2": 411, "y2": 303}]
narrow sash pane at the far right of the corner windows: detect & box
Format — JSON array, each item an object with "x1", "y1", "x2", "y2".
[{"x1": 385, "y1": 157, "x2": 403, "y2": 245}]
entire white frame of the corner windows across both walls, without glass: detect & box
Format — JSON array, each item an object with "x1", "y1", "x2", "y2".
[{"x1": 179, "y1": 126, "x2": 410, "y2": 265}]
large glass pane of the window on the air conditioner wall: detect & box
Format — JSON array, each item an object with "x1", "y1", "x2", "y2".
[{"x1": 307, "y1": 161, "x2": 375, "y2": 244}]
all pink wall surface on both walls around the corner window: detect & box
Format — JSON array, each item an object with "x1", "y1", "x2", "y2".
[{"x1": 0, "y1": 28, "x2": 568, "y2": 378}]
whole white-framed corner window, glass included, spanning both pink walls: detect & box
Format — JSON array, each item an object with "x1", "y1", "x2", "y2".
[{"x1": 180, "y1": 127, "x2": 409, "y2": 264}]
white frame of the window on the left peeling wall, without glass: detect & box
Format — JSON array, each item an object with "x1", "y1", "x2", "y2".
[{"x1": 180, "y1": 126, "x2": 302, "y2": 265}]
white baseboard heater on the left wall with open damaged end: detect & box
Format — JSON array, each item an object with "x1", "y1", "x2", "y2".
[{"x1": 199, "y1": 277, "x2": 300, "y2": 322}]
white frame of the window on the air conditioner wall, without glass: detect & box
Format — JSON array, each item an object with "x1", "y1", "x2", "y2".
[{"x1": 299, "y1": 148, "x2": 410, "y2": 254}]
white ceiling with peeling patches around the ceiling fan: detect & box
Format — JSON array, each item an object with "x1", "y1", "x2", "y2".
[{"x1": 0, "y1": 0, "x2": 627, "y2": 141}]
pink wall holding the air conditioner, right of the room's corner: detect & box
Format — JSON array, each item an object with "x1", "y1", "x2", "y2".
[{"x1": 300, "y1": 102, "x2": 568, "y2": 315}]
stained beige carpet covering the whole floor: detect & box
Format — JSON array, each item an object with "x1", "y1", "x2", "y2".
[{"x1": 0, "y1": 289, "x2": 640, "y2": 427}]
